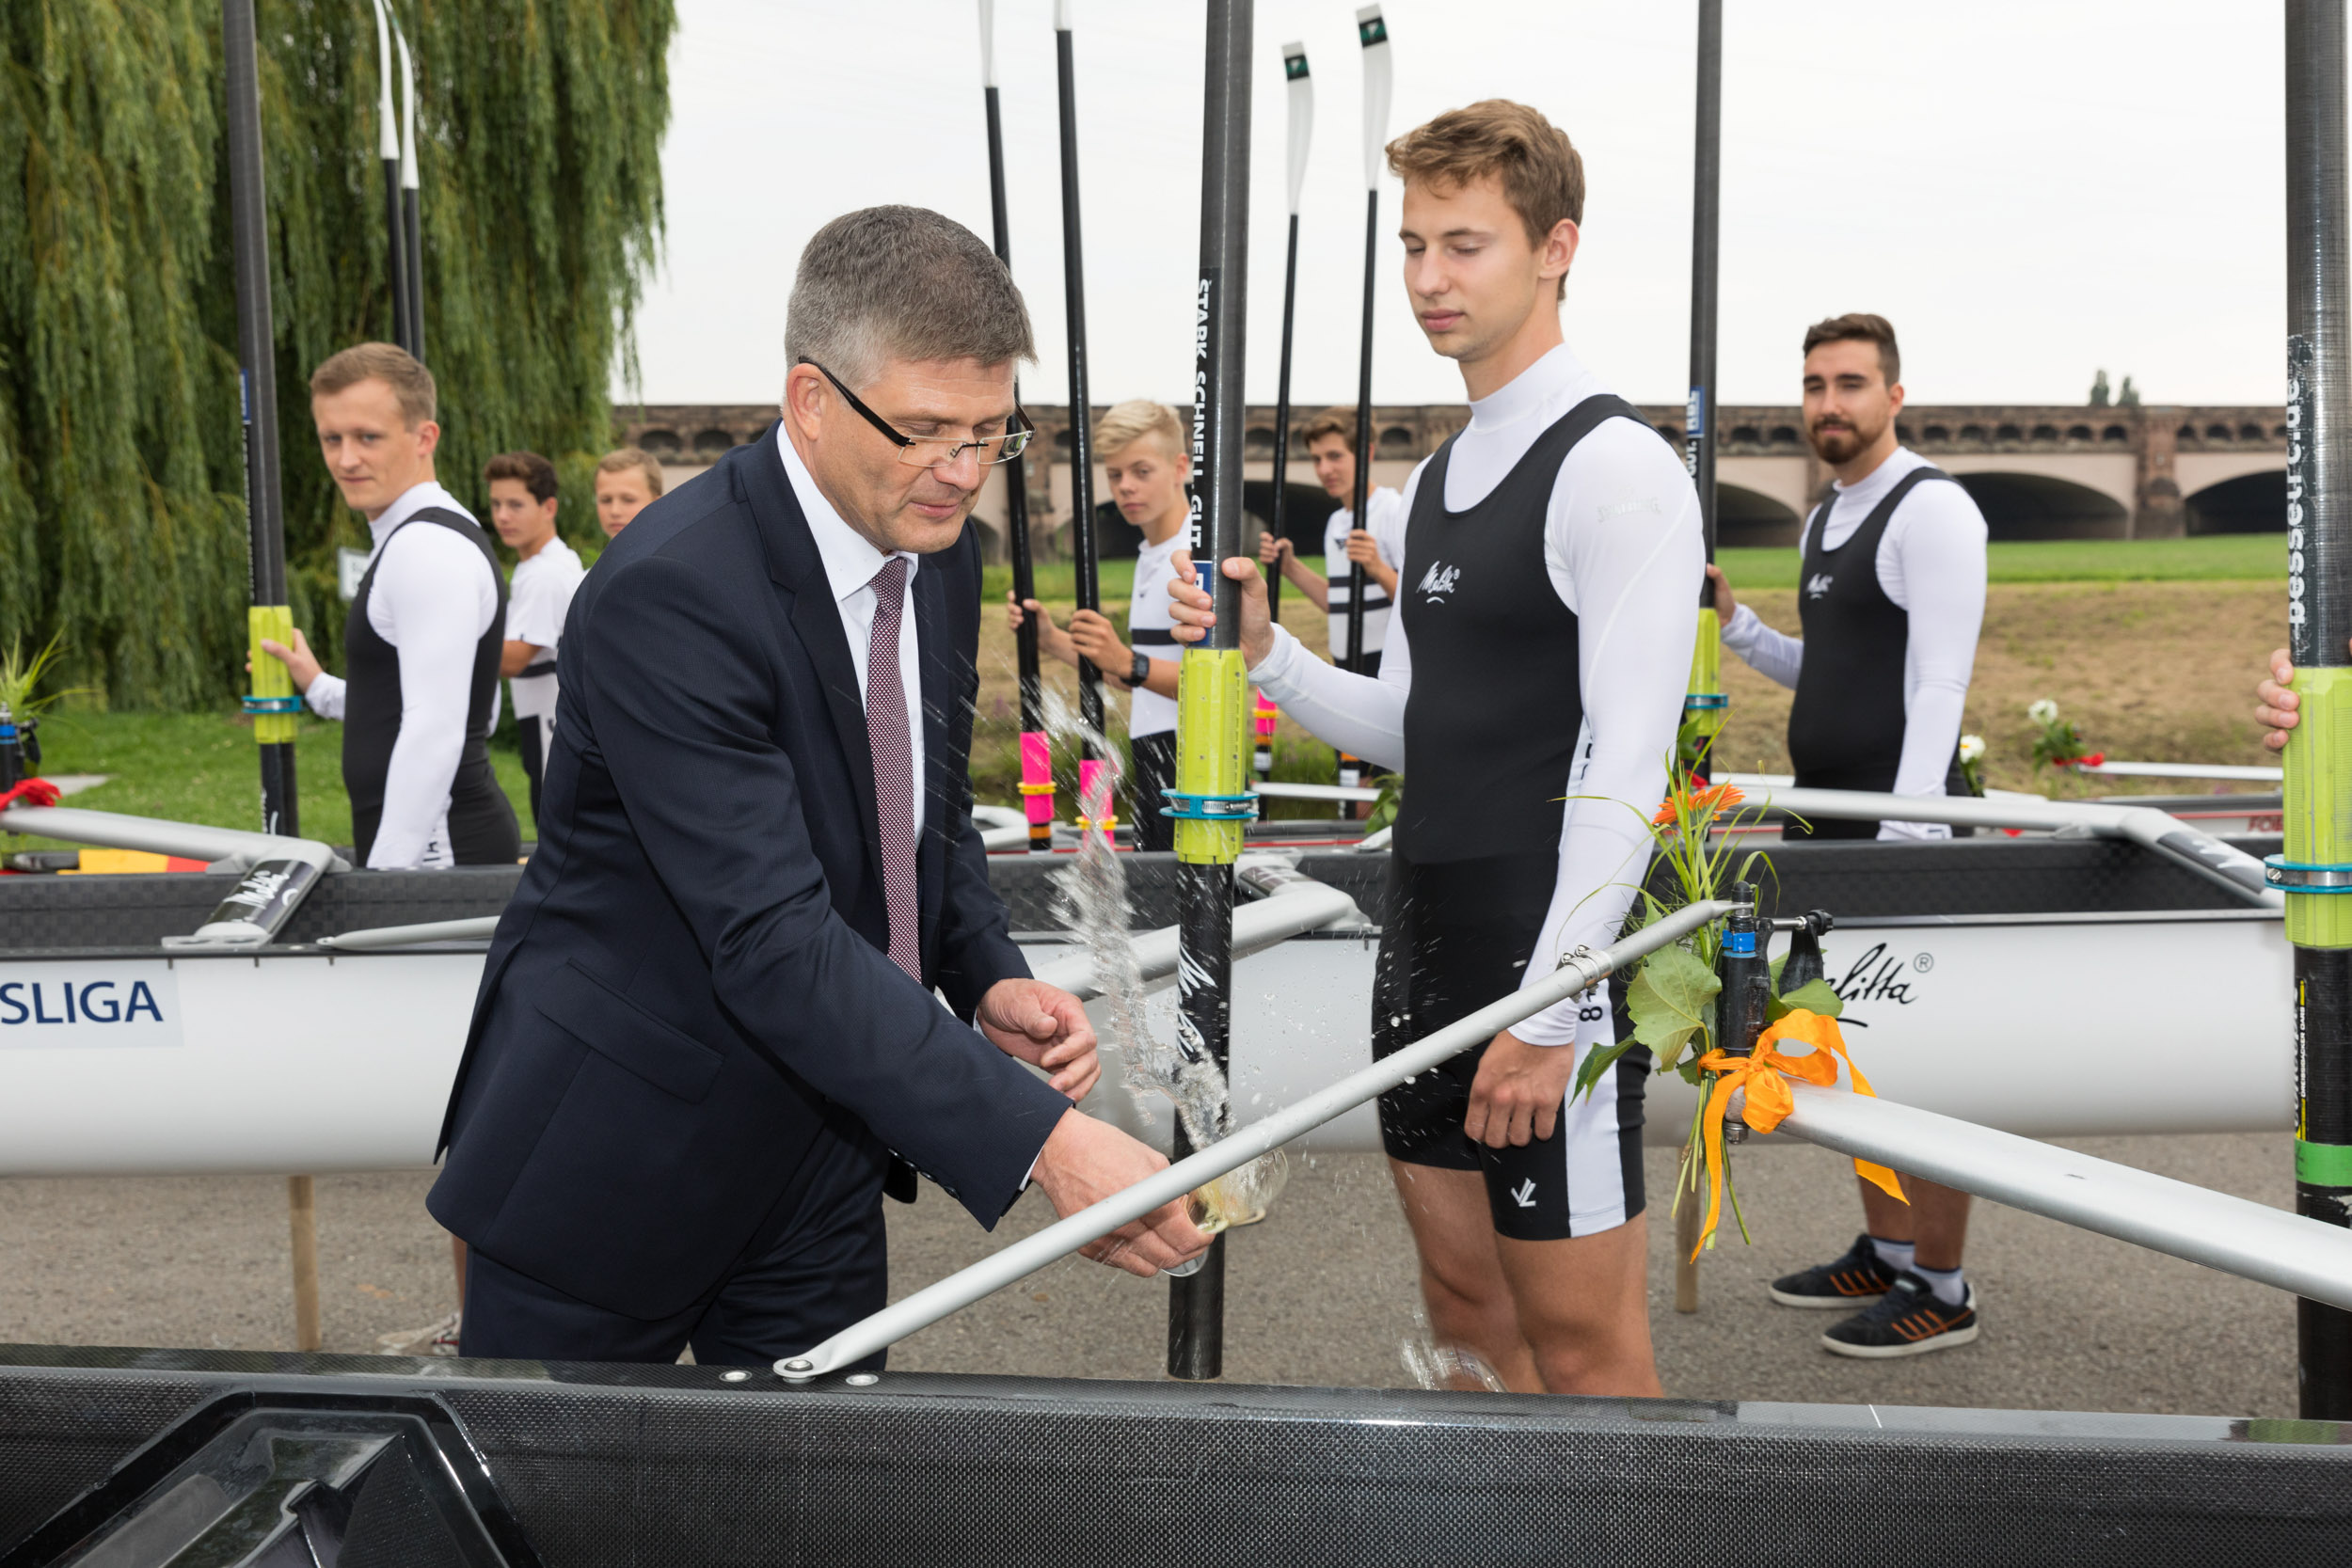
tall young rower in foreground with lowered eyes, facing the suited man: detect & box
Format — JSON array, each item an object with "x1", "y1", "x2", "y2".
[{"x1": 1174, "y1": 99, "x2": 1703, "y2": 1394}]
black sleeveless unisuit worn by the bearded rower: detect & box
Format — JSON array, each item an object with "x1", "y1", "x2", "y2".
[{"x1": 1788, "y1": 467, "x2": 1969, "y2": 839}]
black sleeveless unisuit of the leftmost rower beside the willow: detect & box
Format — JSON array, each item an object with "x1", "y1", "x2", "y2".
[{"x1": 343, "y1": 508, "x2": 522, "y2": 865}]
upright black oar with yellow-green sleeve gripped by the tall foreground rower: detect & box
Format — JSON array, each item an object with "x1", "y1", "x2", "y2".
[{"x1": 1169, "y1": 0, "x2": 1251, "y2": 1378}]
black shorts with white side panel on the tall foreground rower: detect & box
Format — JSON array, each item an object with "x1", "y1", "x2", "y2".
[{"x1": 1372, "y1": 856, "x2": 1651, "y2": 1242}]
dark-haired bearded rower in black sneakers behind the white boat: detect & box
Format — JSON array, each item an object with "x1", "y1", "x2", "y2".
[{"x1": 1708, "y1": 315, "x2": 1985, "y2": 1356}]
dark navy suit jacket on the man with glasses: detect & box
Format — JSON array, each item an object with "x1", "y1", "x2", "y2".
[{"x1": 428, "y1": 428, "x2": 1071, "y2": 1319}]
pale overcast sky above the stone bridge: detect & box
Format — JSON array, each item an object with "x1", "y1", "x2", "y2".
[{"x1": 638, "y1": 0, "x2": 2286, "y2": 404}]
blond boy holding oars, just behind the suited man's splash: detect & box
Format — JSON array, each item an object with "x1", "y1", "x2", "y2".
[{"x1": 1005, "y1": 397, "x2": 1193, "y2": 848}]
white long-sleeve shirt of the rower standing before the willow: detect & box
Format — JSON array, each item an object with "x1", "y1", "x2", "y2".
[{"x1": 304, "y1": 482, "x2": 499, "y2": 872}]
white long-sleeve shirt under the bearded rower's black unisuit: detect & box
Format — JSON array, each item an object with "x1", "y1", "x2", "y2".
[{"x1": 1724, "y1": 447, "x2": 1985, "y2": 839}]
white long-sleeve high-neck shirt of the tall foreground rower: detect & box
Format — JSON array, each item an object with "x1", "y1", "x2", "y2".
[{"x1": 1249, "y1": 345, "x2": 1706, "y2": 1046}]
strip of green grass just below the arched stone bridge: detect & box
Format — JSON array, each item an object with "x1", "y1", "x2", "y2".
[{"x1": 981, "y1": 533, "x2": 2286, "y2": 607}]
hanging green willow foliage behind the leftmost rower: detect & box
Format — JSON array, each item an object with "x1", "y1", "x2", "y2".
[{"x1": 0, "y1": 0, "x2": 675, "y2": 707}]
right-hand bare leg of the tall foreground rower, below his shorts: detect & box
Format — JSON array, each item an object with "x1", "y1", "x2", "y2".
[{"x1": 1496, "y1": 1215, "x2": 1665, "y2": 1399}]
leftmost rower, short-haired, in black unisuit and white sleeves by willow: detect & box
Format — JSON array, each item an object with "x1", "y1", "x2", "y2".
[{"x1": 262, "y1": 343, "x2": 522, "y2": 870}]
